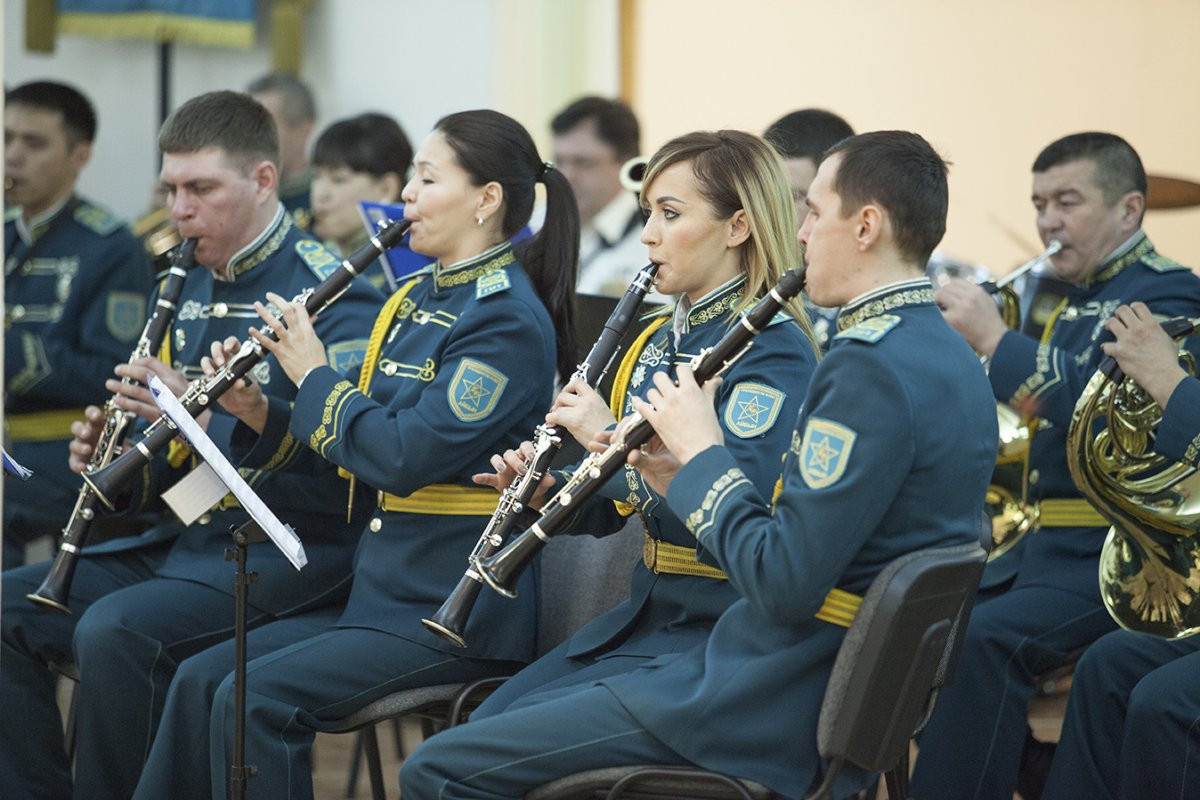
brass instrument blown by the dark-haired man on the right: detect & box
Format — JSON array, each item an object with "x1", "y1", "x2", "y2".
[{"x1": 980, "y1": 239, "x2": 1062, "y2": 560}]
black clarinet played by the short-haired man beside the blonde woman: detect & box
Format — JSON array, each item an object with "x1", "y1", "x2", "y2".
[{"x1": 476, "y1": 270, "x2": 804, "y2": 597}]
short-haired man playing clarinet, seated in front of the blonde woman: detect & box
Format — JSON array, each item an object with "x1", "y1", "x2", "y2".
[{"x1": 401, "y1": 131, "x2": 996, "y2": 800}]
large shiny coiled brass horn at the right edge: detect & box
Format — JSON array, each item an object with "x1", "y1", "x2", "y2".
[{"x1": 1067, "y1": 318, "x2": 1200, "y2": 639}]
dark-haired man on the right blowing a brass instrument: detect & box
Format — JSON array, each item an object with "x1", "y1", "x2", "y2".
[{"x1": 913, "y1": 132, "x2": 1200, "y2": 800}]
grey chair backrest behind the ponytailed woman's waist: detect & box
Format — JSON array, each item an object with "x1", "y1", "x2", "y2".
[{"x1": 538, "y1": 513, "x2": 644, "y2": 656}]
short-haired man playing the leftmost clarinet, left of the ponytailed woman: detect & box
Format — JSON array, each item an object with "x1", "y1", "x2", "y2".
[{"x1": 0, "y1": 91, "x2": 383, "y2": 799}]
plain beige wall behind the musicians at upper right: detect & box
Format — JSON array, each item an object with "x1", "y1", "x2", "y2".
[{"x1": 634, "y1": 0, "x2": 1200, "y2": 272}]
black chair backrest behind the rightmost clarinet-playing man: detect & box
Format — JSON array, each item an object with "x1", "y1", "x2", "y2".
[{"x1": 817, "y1": 542, "x2": 986, "y2": 772}]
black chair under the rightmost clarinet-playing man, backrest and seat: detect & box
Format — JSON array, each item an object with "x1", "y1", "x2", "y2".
[{"x1": 526, "y1": 543, "x2": 986, "y2": 800}]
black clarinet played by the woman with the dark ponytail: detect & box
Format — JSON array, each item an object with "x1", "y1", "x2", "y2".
[{"x1": 83, "y1": 219, "x2": 412, "y2": 509}]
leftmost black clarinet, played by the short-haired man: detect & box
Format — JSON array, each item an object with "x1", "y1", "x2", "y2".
[{"x1": 25, "y1": 239, "x2": 196, "y2": 614}]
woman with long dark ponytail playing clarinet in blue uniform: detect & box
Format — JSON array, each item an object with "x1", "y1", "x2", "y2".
[{"x1": 136, "y1": 110, "x2": 580, "y2": 798}]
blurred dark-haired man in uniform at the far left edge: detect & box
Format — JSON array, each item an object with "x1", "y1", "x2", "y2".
[{"x1": 2, "y1": 80, "x2": 151, "y2": 570}]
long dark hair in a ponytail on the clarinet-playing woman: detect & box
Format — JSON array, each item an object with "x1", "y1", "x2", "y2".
[{"x1": 433, "y1": 109, "x2": 580, "y2": 380}]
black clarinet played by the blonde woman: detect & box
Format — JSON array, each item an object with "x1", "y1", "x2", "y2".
[{"x1": 421, "y1": 261, "x2": 659, "y2": 648}]
